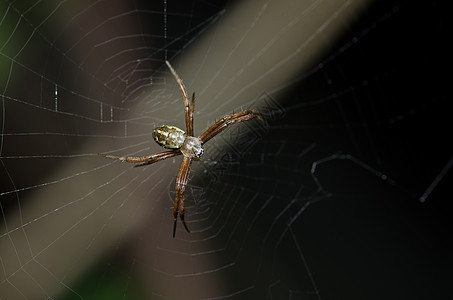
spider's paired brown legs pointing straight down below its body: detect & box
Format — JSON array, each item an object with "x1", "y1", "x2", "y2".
[{"x1": 173, "y1": 157, "x2": 192, "y2": 237}]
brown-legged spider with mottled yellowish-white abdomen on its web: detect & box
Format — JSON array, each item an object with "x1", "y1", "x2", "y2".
[{"x1": 101, "y1": 61, "x2": 265, "y2": 238}]
